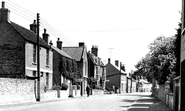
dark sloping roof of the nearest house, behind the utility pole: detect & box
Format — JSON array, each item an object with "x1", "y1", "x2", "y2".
[{"x1": 10, "y1": 22, "x2": 50, "y2": 48}]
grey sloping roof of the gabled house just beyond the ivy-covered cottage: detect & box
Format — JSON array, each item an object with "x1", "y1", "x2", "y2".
[{"x1": 63, "y1": 47, "x2": 84, "y2": 61}]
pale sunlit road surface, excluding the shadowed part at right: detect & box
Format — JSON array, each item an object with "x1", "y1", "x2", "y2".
[{"x1": 0, "y1": 94, "x2": 152, "y2": 111}]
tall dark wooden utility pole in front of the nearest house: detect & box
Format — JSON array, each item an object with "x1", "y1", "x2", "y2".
[{"x1": 37, "y1": 13, "x2": 40, "y2": 101}]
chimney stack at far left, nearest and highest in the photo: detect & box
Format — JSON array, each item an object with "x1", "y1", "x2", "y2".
[{"x1": 0, "y1": 1, "x2": 10, "y2": 22}]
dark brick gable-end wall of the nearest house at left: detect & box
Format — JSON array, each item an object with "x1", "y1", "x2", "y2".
[{"x1": 0, "y1": 23, "x2": 25, "y2": 76}]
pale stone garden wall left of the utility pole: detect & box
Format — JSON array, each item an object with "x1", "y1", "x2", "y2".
[{"x1": 0, "y1": 78, "x2": 35, "y2": 104}]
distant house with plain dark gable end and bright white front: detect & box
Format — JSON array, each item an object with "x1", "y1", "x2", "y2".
[{"x1": 106, "y1": 59, "x2": 127, "y2": 93}]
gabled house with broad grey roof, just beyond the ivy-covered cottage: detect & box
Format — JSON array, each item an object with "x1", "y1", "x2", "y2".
[{"x1": 63, "y1": 42, "x2": 88, "y2": 95}]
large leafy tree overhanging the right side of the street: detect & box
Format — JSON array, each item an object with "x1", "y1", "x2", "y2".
[{"x1": 134, "y1": 36, "x2": 176, "y2": 84}]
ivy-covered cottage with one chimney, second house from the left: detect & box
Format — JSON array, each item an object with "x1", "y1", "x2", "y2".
[{"x1": 52, "y1": 38, "x2": 77, "y2": 86}]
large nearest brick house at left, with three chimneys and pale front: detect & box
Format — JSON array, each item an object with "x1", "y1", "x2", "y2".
[{"x1": 0, "y1": 2, "x2": 53, "y2": 92}]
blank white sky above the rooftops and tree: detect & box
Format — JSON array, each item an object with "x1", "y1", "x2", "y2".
[{"x1": 4, "y1": 0, "x2": 181, "y2": 72}]
